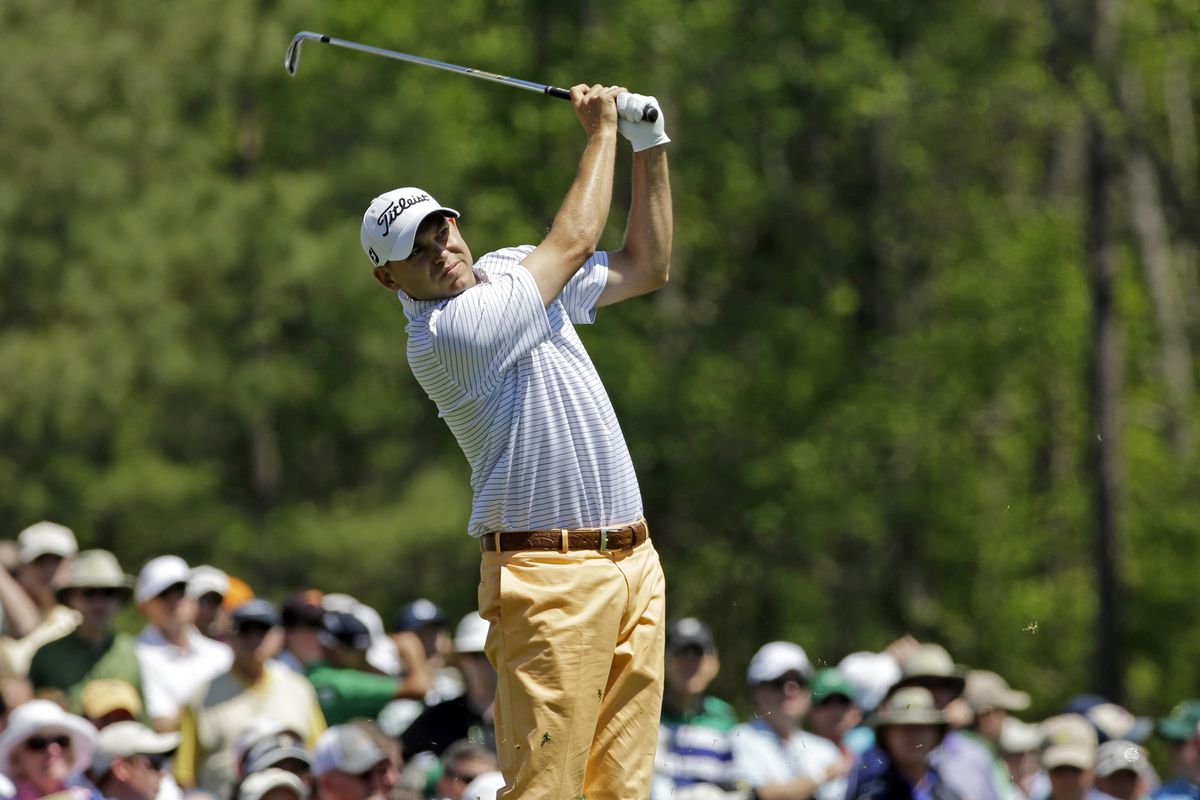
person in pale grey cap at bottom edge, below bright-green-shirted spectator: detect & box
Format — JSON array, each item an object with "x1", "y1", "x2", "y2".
[{"x1": 312, "y1": 724, "x2": 395, "y2": 800}]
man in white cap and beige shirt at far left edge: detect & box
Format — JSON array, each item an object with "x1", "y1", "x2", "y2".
[{"x1": 0, "y1": 522, "x2": 79, "y2": 676}]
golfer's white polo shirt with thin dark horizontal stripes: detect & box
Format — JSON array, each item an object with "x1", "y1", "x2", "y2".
[{"x1": 400, "y1": 245, "x2": 642, "y2": 536}]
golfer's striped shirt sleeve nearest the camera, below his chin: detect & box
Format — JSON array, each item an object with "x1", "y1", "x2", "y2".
[{"x1": 428, "y1": 265, "x2": 551, "y2": 397}]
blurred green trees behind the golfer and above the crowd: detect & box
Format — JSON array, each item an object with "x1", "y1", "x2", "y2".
[{"x1": 0, "y1": 0, "x2": 1200, "y2": 714}]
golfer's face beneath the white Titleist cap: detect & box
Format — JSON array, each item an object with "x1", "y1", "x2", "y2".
[{"x1": 389, "y1": 213, "x2": 475, "y2": 300}]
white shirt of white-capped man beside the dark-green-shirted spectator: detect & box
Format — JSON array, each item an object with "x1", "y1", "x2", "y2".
[{"x1": 137, "y1": 625, "x2": 233, "y2": 718}]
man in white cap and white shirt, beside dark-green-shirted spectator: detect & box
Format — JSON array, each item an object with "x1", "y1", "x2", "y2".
[{"x1": 133, "y1": 555, "x2": 233, "y2": 730}]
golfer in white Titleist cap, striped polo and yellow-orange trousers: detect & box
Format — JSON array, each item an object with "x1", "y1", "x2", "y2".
[{"x1": 361, "y1": 85, "x2": 673, "y2": 800}]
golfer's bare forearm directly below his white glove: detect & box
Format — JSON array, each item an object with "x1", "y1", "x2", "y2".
[{"x1": 623, "y1": 148, "x2": 674, "y2": 290}]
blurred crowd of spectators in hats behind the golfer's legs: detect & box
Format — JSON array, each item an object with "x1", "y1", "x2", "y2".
[{"x1": 0, "y1": 522, "x2": 1200, "y2": 800}]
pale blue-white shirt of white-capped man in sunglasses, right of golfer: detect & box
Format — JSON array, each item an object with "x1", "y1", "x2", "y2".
[{"x1": 730, "y1": 720, "x2": 846, "y2": 800}]
